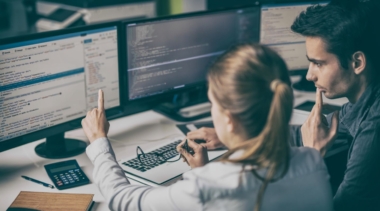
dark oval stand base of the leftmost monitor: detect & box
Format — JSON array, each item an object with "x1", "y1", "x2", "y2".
[{"x1": 34, "y1": 133, "x2": 87, "y2": 159}]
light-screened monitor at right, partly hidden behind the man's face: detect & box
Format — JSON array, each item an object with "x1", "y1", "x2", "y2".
[{"x1": 260, "y1": 1, "x2": 326, "y2": 91}]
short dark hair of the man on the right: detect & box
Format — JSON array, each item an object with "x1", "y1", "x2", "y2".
[{"x1": 291, "y1": 0, "x2": 380, "y2": 78}]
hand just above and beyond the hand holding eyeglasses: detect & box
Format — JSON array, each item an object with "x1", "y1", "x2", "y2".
[{"x1": 187, "y1": 127, "x2": 225, "y2": 150}]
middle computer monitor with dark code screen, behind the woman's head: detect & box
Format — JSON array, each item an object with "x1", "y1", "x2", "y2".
[{"x1": 125, "y1": 7, "x2": 260, "y2": 121}]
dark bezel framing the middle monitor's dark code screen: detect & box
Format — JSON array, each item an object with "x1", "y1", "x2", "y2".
[{"x1": 121, "y1": 5, "x2": 261, "y2": 105}]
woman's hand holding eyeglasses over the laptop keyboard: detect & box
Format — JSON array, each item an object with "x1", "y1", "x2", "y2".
[{"x1": 177, "y1": 139, "x2": 209, "y2": 169}]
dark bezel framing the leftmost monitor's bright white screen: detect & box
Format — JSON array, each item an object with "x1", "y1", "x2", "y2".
[{"x1": 0, "y1": 21, "x2": 125, "y2": 152}]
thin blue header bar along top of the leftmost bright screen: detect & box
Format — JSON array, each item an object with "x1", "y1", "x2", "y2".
[{"x1": 0, "y1": 26, "x2": 116, "y2": 50}]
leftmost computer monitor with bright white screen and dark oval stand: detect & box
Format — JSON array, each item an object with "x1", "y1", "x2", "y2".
[{"x1": 0, "y1": 23, "x2": 121, "y2": 158}]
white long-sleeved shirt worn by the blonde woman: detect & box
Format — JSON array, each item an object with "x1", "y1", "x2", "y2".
[{"x1": 86, "y1": 138, "x2": 333, "y2": 211}]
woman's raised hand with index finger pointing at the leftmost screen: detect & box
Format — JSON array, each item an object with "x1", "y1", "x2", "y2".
[{"x1": 82, "y1": 89, "x2": 110, "y2": 143}]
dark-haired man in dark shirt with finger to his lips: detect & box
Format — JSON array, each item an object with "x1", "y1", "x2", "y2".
[{"x1": 291, "y1": 0, "x2": 380, "y2": 211}]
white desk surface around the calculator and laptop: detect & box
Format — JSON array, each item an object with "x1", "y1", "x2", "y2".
[{"x1": 0, "y1": 89, "x2": 347, "y2": 211}]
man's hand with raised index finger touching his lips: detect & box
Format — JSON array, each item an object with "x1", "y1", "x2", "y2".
[{"x1": 301, "y1": 89, "x2": 339, "y2": 156}]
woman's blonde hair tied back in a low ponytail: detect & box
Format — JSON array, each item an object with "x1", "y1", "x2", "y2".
[{"x1": 208, "y1": 44, "x2": 293, "y2": 211}]
